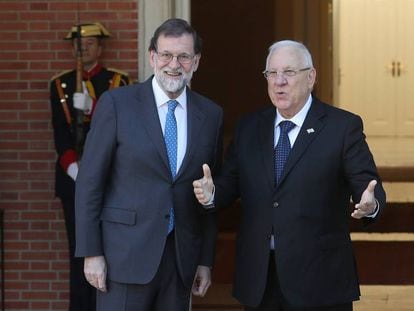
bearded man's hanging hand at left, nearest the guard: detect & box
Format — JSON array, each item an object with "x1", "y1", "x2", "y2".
[{"x1": 83, "y1": 256, "x2": 106, "y2": 292}]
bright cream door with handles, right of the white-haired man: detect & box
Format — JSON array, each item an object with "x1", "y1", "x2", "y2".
[{"x1": 333, "y1": 0, "x2": 414, "y2": 167}]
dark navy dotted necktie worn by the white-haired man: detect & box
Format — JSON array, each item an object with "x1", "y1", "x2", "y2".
[{"x1": 275, "y1": 121, "x2": 295, "y2": 185}]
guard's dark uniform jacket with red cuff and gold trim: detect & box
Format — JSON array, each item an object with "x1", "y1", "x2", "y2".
[{"x1": 50, "y1": 64, "x2": 130, "y2": 200}]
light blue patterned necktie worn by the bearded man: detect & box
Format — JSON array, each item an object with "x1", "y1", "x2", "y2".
[{"x1": 164, "y1": 100, "x2": 178, "y2": 233}]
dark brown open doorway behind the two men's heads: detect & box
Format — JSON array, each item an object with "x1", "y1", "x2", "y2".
[{"x1": 191, "y1": 0, "x2": 333, "y2": 143}]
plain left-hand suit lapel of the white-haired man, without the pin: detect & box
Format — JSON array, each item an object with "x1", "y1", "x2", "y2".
[{"x1": 259, "y1": 106, "x2": 276, "y2": 188}]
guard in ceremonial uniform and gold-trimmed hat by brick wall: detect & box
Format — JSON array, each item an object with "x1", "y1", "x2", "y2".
[{"x1": 50, "y1": 23, "x2": 130, "y2": 311}]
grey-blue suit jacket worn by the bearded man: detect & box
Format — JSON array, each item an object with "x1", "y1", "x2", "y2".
[{"x1": 75, "y1": 79, "x2": 223, "y2": 286}]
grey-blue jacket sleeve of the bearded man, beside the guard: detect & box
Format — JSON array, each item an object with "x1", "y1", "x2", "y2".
[{"x1": 75, "y1": 93, "x2": 117, "y2": 257}]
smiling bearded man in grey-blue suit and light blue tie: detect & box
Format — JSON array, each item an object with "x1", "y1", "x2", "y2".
[{"x1": 76, "y1": 19, "x2": 223, "y2": 311}]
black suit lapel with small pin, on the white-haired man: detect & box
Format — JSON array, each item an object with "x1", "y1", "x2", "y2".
[{"x1": 279, "y1": 99, "x2": 325, "y2": 185}]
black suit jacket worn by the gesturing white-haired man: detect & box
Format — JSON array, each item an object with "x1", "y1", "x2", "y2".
[{"x1": 215, "y1": 99, "x2": 385, "y2": 307}]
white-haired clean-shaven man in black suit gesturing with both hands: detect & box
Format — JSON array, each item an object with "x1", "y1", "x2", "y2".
[{"x1": 193, "y1": 41, "x2": 385, "y2": 311}]
